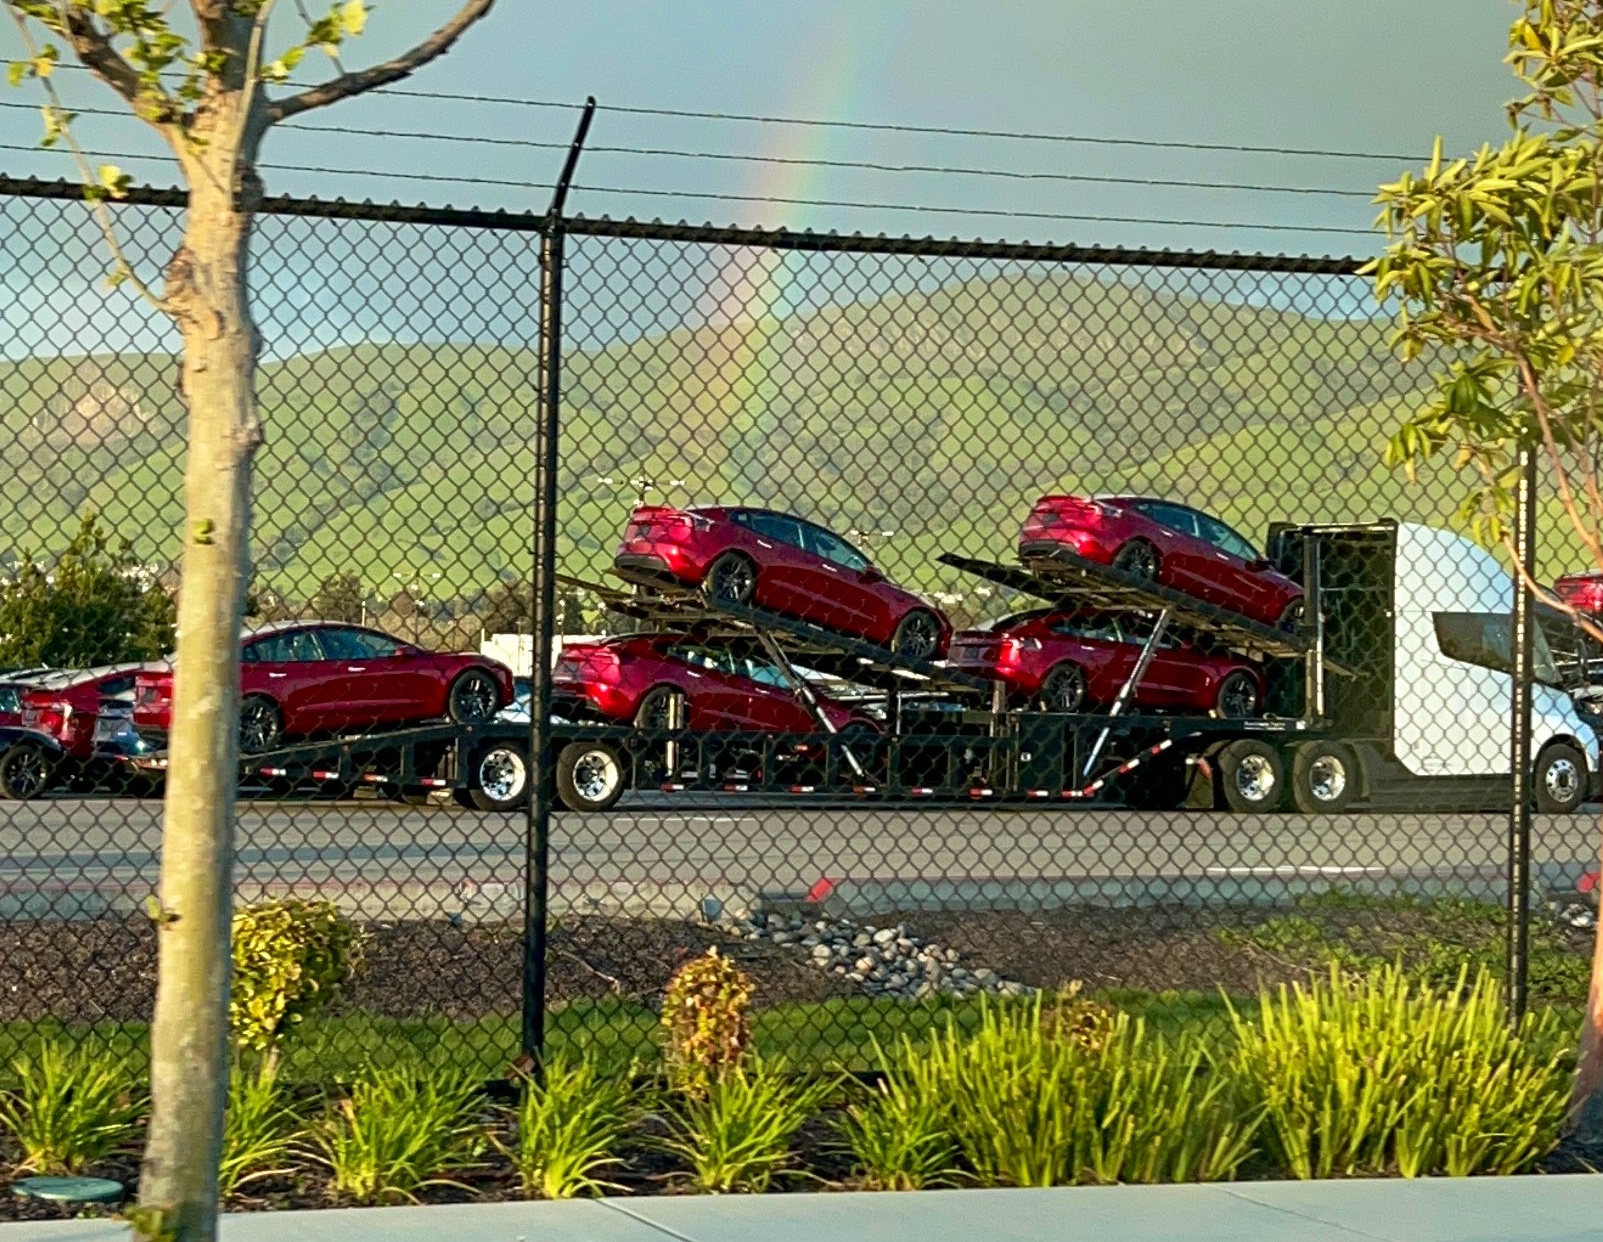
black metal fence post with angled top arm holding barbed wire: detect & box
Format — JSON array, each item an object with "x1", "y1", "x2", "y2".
[{"x1": 519, "y1": 98, "x2": 596, "y2": 1072}]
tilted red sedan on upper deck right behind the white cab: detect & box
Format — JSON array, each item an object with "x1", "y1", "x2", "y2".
[{"x1": 1018, "y1": 495, "x2": 1302, "y2": 628}]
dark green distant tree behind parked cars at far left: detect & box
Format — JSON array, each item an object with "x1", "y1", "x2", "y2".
[{"x1": 0, "y1": 513, "x2": 175, "y2": 668}]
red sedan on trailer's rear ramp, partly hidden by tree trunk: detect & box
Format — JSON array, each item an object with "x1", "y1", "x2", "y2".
[{"x1": 133, "y1": 620, "x2": 513, "y2": 755}]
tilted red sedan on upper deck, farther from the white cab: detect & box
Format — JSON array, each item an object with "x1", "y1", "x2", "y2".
[{"x1": 612, "y1": 505, "x2": 952, "y2": 660}]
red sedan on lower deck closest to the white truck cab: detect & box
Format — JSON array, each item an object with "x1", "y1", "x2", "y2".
[{"x1": 951, "y1": 609, "x2": 1263, "y2": 720}]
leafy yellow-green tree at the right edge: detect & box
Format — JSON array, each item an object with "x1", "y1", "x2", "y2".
[{"x1": 1372, "y1": 0, "x2": 1603, "y2": 1130}]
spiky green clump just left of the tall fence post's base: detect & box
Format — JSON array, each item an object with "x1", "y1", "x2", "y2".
[{"x1": 313, "y1": 1066, "x2": 489, "y2": 1204}]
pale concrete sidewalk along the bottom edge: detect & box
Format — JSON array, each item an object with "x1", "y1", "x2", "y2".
[{"x1": 0, "y1": 1176, "x2": 1603, "y2": 1242}]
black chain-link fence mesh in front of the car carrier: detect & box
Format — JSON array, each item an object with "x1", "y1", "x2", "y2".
[{"x1": 0, "y1": 174, "x2": 1598, "y2": 1077}]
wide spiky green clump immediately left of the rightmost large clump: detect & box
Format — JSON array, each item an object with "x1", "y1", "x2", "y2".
[{"x1": 929, "y1": 998, "x2": 1257, "y2": 1186}]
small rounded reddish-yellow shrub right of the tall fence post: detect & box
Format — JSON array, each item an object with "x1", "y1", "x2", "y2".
[{"x1": 662, "y1": 946, "x2": 752, "y2": 1093}]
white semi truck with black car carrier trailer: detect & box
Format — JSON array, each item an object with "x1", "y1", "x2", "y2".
[{"x1": 116, "y1": 521, "x2": 1598, "y2": 813}]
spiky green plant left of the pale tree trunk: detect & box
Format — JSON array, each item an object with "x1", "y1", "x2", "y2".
[{"x1": 0, "y1": 1040, "x2": 149, "y2": 1176}]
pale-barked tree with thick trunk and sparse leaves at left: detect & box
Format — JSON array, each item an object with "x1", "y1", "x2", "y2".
[{"x1": 0, "y1": 0, "x2": 495, "y2": 1242}]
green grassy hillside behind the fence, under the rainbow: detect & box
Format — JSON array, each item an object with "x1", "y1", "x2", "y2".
[{"x1": 0, "y1": 272, "x2": 1574, "y2": 618}]
